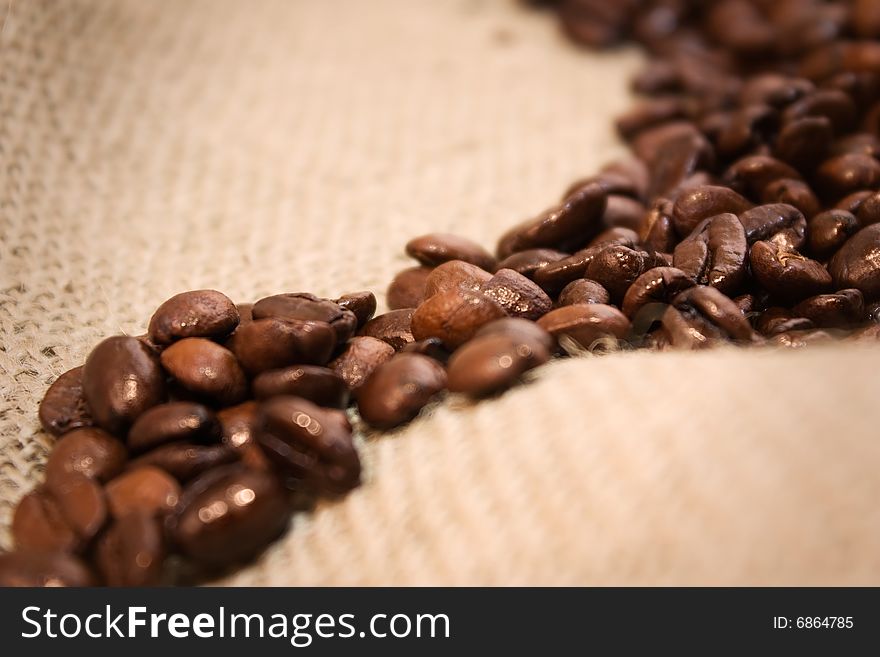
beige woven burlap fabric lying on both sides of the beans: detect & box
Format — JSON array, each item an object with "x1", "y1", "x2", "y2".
[{"x1": 0, "y1": 0, "x2": 880, "y2": 585}]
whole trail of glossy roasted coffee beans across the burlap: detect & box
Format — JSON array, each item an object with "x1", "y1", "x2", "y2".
[{"x1": 0, "y1": 0, "x2": 880, "y2": 585}]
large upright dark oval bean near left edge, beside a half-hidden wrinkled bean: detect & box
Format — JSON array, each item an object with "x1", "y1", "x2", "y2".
[{"x1": 82, "y1": 335, "x2": 165, "y2": 435}]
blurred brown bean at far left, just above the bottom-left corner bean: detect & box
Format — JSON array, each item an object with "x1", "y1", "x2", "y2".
[{"x1": 11, "y1": 486, "x2": 82, "y2": 552}]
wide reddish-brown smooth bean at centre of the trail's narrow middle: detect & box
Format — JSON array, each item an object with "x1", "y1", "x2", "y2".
[{"x1": 412, "y1": 288, "x2": 508, "y2": 349}]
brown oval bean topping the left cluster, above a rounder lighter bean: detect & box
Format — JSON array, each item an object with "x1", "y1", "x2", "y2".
[{"x1": 149, "y1": 290, "x2": 239, "y2": 345}]
